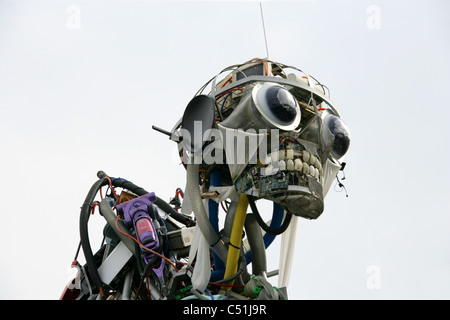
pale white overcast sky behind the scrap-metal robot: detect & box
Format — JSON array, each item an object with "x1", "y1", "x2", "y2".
[{"x1": 0, "y1": 0, "x2": 450, "y2": 299}]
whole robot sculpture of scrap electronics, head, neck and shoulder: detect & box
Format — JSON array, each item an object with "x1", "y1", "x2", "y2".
[{"x1": 61, "y1": 59, "x2": 350, "y2": 300}]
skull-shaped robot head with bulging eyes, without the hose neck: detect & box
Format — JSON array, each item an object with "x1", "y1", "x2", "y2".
[{"x1": 172, "y1": 59, "x2": 350, "y2": 219}]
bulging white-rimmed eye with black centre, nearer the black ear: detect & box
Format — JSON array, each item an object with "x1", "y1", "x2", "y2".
[{"x1": 258, "y1": 85, "x2": 300, "y2": 126}]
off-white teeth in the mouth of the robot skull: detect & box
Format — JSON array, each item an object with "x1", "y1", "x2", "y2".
[{"x1": 264, "y1": 149, "x2": 323, "y2": 179}]
